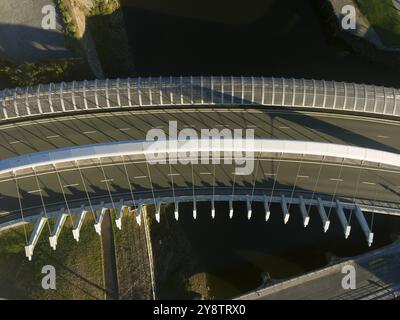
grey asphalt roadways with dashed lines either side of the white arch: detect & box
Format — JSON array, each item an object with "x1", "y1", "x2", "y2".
[{"x1": 0, "y1": 108, "x2": 400, "y2": 220}]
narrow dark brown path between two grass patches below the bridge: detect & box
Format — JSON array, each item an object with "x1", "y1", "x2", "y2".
[{"x1": 101, "y1": 214, "x2": 119, "y2": 300}]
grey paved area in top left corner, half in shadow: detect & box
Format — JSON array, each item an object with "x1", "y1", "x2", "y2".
[{"x1": 0, "y1": 0, "x2": 71, "y2": 63}]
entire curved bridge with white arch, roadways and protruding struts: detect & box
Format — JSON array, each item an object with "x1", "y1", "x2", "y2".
[{"x1": 0, "y1": 77, "x2": 400, "y2": 258}]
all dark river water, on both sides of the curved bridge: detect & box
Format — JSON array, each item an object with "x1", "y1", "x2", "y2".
[{"x1": 122, "y1": 0, "x2": 400, "y2": 298}]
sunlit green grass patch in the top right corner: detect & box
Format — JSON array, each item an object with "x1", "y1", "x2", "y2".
[{"x1": 358, "y1": 0, "x2": 400, "y2": 47}]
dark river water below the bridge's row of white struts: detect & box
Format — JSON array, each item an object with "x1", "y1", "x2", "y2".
[{"x1": 168, "y1": 202, "x2": 400, "y2": 298}]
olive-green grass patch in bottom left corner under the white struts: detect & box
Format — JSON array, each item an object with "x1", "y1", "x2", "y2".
[{"x1": 0, "y1": 216, "x2": 105, "y2": 299}]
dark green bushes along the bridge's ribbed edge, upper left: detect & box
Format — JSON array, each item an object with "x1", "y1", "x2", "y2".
[{"x1": 0, "y1": 59, "x2": 92, "y2": 87}]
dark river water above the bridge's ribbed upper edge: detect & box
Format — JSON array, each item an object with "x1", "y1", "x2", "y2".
[{"x1": 122, "y1": 0, "x2": 399, "y2": 87}]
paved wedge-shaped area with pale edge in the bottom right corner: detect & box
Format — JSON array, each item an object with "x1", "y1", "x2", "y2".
[{"x1": 241, "y1": 243, "x2": 400, "y2": 300}]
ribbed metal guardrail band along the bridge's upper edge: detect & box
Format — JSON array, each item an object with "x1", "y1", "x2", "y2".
[{"x1": 0, "y1": 76, "x2": 400, "y2": 122}]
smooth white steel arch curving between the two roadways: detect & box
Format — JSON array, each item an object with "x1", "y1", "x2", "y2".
[{"x1": 0, "y1": 139, "x2": 400, "y2": 175}]
